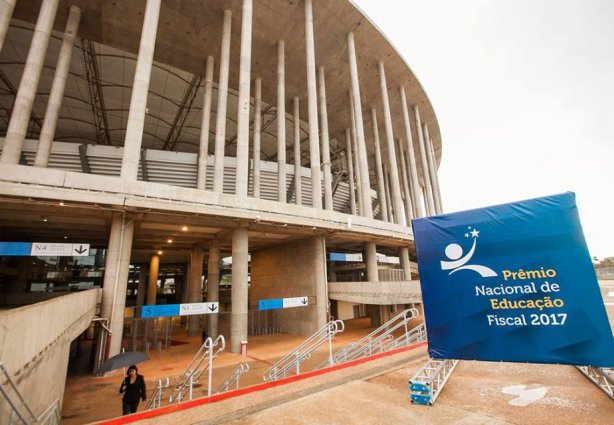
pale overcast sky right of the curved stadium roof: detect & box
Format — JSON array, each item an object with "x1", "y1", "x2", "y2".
[{"x1": 353, "y1": 0, "x2": 614, "y2": 259}]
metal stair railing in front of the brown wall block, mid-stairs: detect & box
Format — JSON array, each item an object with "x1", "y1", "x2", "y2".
[{"x1": 263, "y1": 320, "x2": 345, "y2": 381}]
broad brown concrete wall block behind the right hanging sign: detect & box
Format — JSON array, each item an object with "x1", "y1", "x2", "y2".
[{"x1": 249, "y1": 237, "x2": 328, "y2": 336}]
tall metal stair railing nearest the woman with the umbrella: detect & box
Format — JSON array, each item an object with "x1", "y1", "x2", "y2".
[{"x1": 169, "y1": 335, "x2": 226, "y2": 403}]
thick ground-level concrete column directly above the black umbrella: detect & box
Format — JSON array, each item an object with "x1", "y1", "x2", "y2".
[{"x1": 100, "y1": 213, "x2": 134, "y2": 357}]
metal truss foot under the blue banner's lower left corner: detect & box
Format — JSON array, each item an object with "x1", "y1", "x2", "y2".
[{"x1": 409, "y1": 359, "x2": 458, "y2": 406}]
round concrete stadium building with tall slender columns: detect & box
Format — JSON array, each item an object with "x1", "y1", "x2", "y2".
[{"x1": 0, "y1": 0, "x2": 441, "y2": 410}]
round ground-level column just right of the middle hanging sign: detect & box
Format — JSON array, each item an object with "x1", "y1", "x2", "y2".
[{"x1": 230, "y1": 227, "x2": 248, "y2": 354}]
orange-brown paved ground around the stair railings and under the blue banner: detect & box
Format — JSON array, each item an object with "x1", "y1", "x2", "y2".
[{"x1": 62, "y1": 281, "x2": 614, "y2": 425}]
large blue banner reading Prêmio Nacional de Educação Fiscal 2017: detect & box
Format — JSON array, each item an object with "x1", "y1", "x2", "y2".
[{"x1": 412, "y1": 193, "x2": 614, "y2": 367}]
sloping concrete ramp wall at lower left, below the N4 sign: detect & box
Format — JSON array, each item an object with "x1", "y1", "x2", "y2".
[{"x1": 0, "y1": 289, "x2": 100, "y2": 414}]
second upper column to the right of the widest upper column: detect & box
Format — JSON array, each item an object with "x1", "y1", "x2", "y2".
[{"x1": 213, "y1": 10, "x2": 232, "y2": 193}]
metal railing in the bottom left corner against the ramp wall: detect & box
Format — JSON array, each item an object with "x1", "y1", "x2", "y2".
[{"x1": 0, "y1": 363, "x2": 61, "y2": 425}]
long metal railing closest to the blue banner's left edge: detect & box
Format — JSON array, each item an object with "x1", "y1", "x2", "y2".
[{"x1": 316, "y1": 308, "x2": 419, "y2": 369}]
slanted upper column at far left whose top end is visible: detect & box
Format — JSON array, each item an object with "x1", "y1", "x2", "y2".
[{"x1": 34, "y1": 6, "x2": 81, "y2": 167}]
